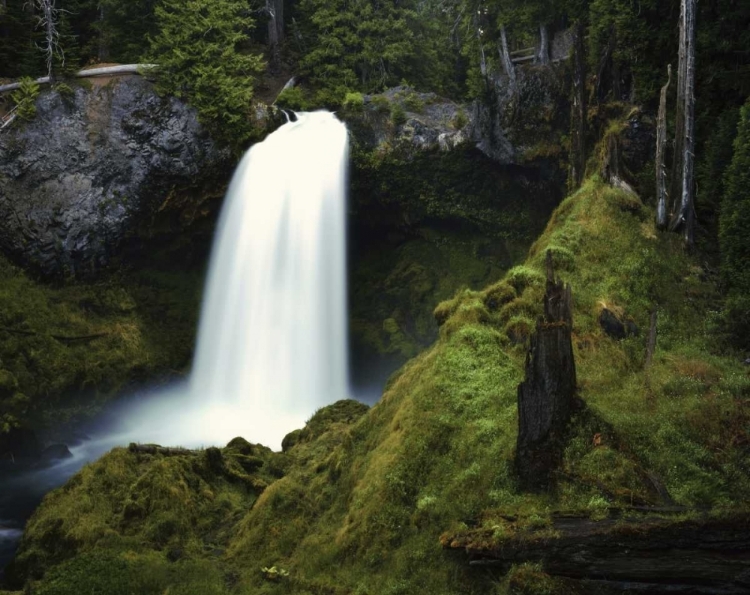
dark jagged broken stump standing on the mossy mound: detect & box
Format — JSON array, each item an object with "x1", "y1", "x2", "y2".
[{"x1": 516, "y1": 252, "x2": 576, "y2": 491}]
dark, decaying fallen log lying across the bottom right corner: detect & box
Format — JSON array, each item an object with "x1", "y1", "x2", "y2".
[{"x1": 441, "y1": 509, "x2": 750, "y2": 595}]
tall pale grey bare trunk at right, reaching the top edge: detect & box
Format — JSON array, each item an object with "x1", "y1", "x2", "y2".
[{"x1": 670, "y1": 0, "x2": 696, "y2": 246}]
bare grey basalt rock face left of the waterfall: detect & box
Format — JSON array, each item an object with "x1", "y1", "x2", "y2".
[{"x1": 0, "y1": 76, "x2": 233, "y2": 277}]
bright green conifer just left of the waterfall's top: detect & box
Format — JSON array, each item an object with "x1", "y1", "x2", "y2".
[{"x1": 149, "y1": 0, "x2": 264, "y2": 148}]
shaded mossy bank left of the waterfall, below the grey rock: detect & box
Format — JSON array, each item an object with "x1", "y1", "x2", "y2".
[{"x1": 0, "y1": 258, "x2": 202, "y2": 431}]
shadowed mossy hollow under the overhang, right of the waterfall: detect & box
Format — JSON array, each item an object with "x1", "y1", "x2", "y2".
[{"x1": 350, "y1": 144, "x2": 560, "y2": 369}]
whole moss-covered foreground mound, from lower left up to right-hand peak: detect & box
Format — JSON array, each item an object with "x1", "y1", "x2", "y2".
[{"x1": 7, "y1": 179, "x2": 750, "y2": 595}]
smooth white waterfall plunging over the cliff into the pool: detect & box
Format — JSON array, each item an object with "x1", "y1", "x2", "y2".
[{"x1": 119, "y1": 112, "x2": 348, "y2": 448}]
